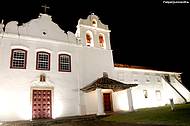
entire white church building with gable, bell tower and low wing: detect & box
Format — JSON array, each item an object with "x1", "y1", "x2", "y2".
[{"x1": 0, "y1": 14, "x2": 190, "y2": 121}]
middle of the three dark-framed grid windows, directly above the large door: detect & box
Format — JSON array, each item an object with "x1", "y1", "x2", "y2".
[{"x1": 36, "y1": 52, "x2": 50, "y2": 70}]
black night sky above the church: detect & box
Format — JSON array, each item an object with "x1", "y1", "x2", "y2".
[{"x1": 0, "y1": 0, "x2": 190, "y2": 87}]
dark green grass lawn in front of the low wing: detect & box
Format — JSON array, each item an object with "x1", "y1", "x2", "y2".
[{"x1": 103, "y1": 104, "x2": 190, "y2": 126}]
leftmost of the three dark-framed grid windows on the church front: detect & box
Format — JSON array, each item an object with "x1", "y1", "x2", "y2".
[{"x1": 10, "y1": 49, "x2": 27, "y2": 69}]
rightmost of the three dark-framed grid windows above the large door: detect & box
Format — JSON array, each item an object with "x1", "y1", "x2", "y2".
[{"x1": 59, "y1": 54, "x2": 71, "y2": 72}]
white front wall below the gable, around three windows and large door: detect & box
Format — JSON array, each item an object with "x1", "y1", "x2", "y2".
[{"x1": 0, "y1": 35, "x2": 79, "y2": 120}]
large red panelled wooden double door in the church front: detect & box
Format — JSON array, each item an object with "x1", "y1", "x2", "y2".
[{"x1": 32, "y1": 90, "x2": 52, "y2": 119}]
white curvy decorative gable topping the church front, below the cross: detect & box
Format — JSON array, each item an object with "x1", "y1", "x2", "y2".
[{"x1": 5, "y1": 14, "x2": 77, "y2": 44}]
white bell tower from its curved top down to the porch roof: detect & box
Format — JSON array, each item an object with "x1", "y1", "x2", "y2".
[{"x1": 75, "y1": 13, "x2": 114, "y2": 87}]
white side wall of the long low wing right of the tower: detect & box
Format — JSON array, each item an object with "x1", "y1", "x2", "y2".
[{"x1": 113, "y1": 67, "x2": 190, "y2": 109}]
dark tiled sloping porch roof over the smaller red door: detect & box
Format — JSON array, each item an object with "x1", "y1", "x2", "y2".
[{"x1": 80, "y1": 76, "x2": 137, "y2": 93}]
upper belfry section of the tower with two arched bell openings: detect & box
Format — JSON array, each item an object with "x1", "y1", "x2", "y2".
[{"x1": 76, "y1": 13, "x2": 111, "y2": 50}]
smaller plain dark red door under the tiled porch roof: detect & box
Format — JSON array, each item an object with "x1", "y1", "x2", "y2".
[{"x1": 103, "y1": 93, "x2": 112, "y2": 112}]
